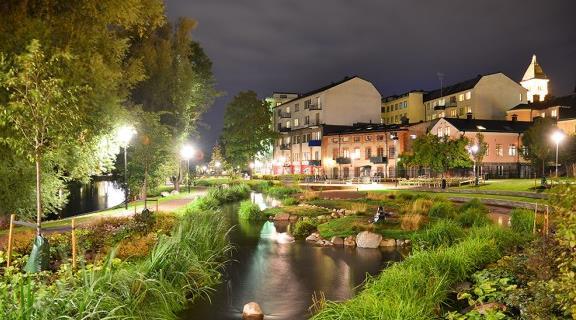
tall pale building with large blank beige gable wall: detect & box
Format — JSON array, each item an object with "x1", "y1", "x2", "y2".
[{"x1": 272, "y1": 77, "x2": 381, "y2": 174}]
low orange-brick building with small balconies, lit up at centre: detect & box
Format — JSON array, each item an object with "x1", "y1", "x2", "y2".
[{"x1": 322, "y1": 123, "x2": 416, "y2": 181}]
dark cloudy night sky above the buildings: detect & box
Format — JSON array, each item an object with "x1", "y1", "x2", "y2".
[{"x1": 166, "y1": 0, "x2": 576, "y2": 155}]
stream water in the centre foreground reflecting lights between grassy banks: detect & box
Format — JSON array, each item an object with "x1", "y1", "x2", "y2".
[{"x1": 181, "y1": 194, "x2": 401, "y2": 320}]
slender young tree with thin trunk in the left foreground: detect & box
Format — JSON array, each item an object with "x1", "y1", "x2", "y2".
[{"x1": 0, "y1": 41, "x2": 87, "y2": 236}]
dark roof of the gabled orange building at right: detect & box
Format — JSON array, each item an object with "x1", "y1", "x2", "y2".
[{"x1": 444, "y1": 118, "x2": 532, "y2": 133}]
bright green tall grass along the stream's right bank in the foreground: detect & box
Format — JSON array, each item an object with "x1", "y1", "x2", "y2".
[{"x1": 312, "y1": 227, "x2": 524, "y2": 320}]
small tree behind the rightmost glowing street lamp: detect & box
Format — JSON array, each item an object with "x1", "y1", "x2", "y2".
[{"x1": 522, "y1": 118, "x2": 556, "y2": 177}]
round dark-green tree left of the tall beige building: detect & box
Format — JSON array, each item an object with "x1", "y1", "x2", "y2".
[{"x1": 220, "y1": 91, "x2": 275, "y2": 168}]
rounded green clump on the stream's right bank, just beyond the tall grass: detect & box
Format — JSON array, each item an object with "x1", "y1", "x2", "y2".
[{"x1": 412, "y1": 220, "x2": 466, "y2": 249}]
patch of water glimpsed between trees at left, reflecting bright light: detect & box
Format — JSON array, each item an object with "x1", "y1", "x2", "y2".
[{"x1": 59, "y1": 181, "x2": 124, "y2": 218}]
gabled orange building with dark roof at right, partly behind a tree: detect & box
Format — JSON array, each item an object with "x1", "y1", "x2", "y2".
[{"x1": 430, "y1": 118, "x2": 532, "y2": 178}]
